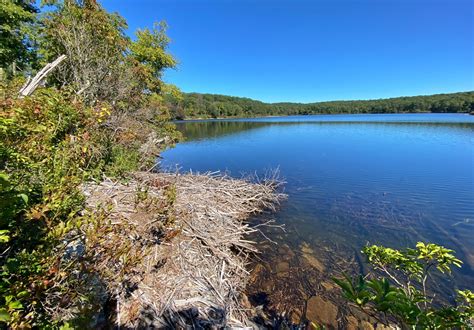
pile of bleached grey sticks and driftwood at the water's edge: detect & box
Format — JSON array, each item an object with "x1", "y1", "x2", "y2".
[{"x1": 83, "y1": 173, "x2": 285, "y2": 328}]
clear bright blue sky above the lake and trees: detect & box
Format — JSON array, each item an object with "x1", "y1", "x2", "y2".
[{"x1": 99, "y1": 0, "x2": 474, "y2": 102}]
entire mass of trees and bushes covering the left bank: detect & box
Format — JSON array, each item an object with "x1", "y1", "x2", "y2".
[{"x1": 0, "y1": 0, "x2": 180, "y2": 328}]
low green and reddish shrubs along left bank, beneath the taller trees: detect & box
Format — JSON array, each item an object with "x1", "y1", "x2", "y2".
[{"x1": 0, "y1": 83, "x2": 179, "y2": 327}]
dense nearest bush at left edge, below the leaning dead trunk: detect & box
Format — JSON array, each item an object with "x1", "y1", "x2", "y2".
[{"x1": 0, "y1": 84, "x2": 101, "y2": 327}]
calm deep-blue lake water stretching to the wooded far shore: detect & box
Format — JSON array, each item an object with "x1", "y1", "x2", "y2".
[{"x1": 162, "y1": 114, "x2": 474, "y2": 312}]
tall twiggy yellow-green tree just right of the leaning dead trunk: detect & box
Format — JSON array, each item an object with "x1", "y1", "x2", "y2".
[{"x1": 40, "y1": 0, "x2": 130, "y2": 104}]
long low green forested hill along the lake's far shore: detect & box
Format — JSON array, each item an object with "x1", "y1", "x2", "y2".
[{"x1": 168, "y1": 91, "x2": 474, "y2": 119}]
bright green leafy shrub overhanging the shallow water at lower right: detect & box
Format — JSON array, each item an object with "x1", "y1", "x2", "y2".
[{"x1": 334, "y1": 242, "x2": 474, "y2": 329}]
